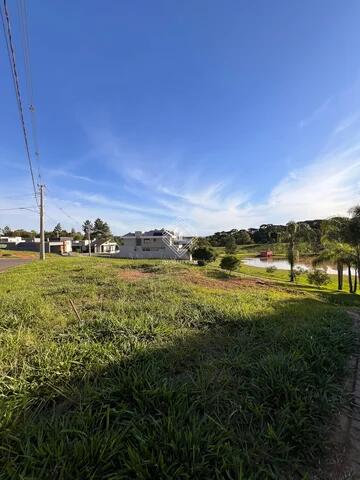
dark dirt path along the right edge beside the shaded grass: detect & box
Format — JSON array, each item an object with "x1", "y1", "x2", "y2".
[{"x1": 314, "y1": 310, "x2": 360, "y2": 480}]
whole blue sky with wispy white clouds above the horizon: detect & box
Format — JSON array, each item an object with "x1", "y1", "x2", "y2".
[{"x1": 0, "y1": 0, "x2": 360, "y2": 234}]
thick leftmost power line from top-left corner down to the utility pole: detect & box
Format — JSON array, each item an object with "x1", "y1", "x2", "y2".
[{"x1": 0, "y1": 0, "x2": 39, "y2": 206}]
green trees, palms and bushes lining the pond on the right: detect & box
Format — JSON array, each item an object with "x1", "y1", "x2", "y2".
[{"x1": 192, "y1": 205, "x2": 360, "y2": 293}]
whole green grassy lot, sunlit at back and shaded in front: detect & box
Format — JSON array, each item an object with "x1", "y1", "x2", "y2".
[{"x1": 0, "y1": 257, "x2": 353, "y2": 480}]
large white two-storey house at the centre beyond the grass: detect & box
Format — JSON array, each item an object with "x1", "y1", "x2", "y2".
[{"x1": 115, "y1": 229, "x2": 191, "y2": 260}]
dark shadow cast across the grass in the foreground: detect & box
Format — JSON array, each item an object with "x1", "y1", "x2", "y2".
[{"x1": 0, "y1": 298, "x2": 352, "y2": 480}]
